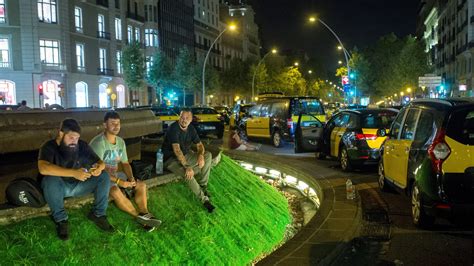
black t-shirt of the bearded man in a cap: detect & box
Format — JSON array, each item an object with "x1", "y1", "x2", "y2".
[{"x1": 38, "y1": 139, "x2": 100, "y2": 169}]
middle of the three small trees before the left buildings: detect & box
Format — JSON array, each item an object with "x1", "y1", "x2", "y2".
[{"x1": 148, "y1": 50, "x2": 173, "y2": 105}]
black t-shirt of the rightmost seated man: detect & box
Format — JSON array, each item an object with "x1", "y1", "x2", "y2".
[{"x1": 161, "y1": 122, "x2": 201, "y2": 161}]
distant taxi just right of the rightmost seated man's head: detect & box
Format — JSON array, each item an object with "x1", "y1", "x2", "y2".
[{"x1": 190, "y1": 106, "x2": 224, "y2": 139}]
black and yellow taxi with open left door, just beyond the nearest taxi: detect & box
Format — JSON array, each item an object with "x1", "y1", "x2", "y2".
[{"x1": 295, "y1": 108, "x2": 398, "y2": 171}]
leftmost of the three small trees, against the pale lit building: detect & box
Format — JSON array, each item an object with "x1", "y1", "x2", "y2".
[{"x1": 122, "y1": 42, "x2": 145, "y2": 104}]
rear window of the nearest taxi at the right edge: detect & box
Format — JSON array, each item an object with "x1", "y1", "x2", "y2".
[{"x1": 446, "y1": 107, "x2": 474, "y2": 145}]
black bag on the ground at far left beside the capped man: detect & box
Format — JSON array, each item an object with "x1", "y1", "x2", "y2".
[{"x1": 5, "y1": 177, "x2": 46, "y2": 208}]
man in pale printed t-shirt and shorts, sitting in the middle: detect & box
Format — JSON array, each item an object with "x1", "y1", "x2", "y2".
[{"x1": 90, "y1": 111, "x2": 161, "y2": 231}]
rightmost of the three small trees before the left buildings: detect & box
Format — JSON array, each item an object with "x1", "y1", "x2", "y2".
[{"x1": 172, "y1": 46, "x2": 199, "y2": 105}]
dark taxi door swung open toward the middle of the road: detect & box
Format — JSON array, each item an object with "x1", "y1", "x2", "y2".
[{"x1": 295, "y1": 114, "x2": 324, "y2": 153}]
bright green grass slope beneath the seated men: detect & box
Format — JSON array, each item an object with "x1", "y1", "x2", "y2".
[{"x1": 0, "y1": 156, "x2": 291, "y2": 265}]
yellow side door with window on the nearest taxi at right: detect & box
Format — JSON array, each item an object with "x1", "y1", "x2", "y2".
[{"x1": 383, "y1": 109, "x2": 420, "y2": 189}]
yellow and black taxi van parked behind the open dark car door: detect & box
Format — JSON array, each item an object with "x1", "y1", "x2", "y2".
[{"x1": 243, "y1": 96, "x2": 326, "y2": 147}]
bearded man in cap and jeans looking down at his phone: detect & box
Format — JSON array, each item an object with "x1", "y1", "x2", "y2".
[{"x1": 38, "y1": 118, "x2": 114, "y2": 240}]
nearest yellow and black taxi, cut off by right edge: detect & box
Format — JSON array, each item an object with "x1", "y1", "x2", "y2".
[{"x1": 379, "y1": 98, "x2": 474, "y2": 227}]
